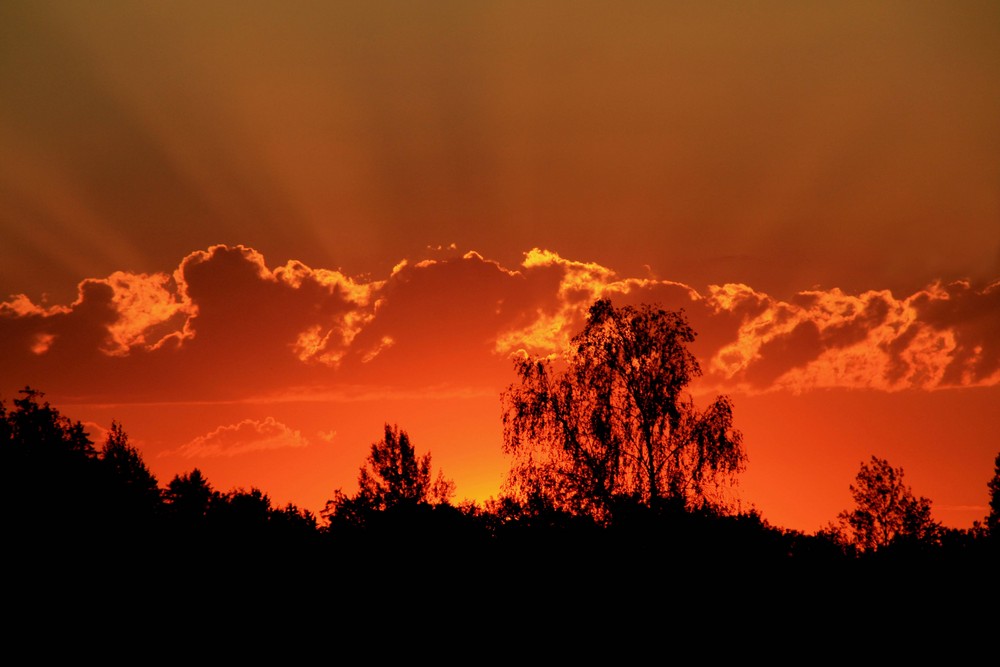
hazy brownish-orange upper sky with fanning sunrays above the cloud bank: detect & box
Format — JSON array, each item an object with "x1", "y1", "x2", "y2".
[{"x1": 0, "y1": 0, "x2": 1000, "y2": 295}]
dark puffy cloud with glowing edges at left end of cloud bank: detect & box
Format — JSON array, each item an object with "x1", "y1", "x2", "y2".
[{"x1": 0, "y1": 245, "x2": 382, "y2": 400}]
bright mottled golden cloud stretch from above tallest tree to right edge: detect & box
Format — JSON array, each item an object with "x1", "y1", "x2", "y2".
[{"x1": 486, "y1": 249, "x2": 1000, "y2": 392}]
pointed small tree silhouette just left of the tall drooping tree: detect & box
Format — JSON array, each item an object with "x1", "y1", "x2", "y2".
[{"x1": 323, "y1": 424, "x2": 455, "y2": 524}]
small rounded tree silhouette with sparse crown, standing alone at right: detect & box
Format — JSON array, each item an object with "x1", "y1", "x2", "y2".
[{"x1": 838, "y1": 456, "x2": 941, "y2": 552}]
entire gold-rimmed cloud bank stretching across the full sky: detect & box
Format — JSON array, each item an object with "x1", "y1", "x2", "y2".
[{"x1": 0, "y1": 245, "x2": 1000, "y2": 401}]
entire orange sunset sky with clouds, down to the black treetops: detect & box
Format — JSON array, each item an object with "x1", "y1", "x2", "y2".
[{"x1": 0, "y1": 0, "x2": 1000, "y2": 532}]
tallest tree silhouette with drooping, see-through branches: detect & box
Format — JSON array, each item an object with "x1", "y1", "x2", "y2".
[{"x1": 502, "y1": 299, "x2": 746, "y2": 520}]
